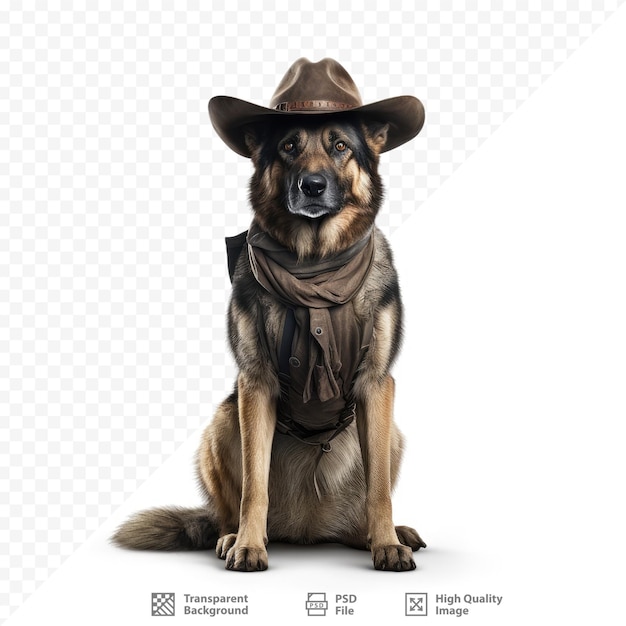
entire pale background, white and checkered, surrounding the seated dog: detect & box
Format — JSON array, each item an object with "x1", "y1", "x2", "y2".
[{"x1": 0, "y1": 5, "x2": 626, "y2": 625}]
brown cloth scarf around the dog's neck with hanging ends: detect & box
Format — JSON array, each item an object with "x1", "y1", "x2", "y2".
[{"x1": 247, "y1": 223, "x2": 374, "y2": 403}]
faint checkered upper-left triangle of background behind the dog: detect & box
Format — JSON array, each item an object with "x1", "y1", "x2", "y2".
[{"x1": 0, "y1": 0, "x2": 622, "y2": 619}]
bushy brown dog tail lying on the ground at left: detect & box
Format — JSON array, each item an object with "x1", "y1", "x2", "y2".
[{"x1": 111, "y1": 507, "x2": 219, "y2": 550}]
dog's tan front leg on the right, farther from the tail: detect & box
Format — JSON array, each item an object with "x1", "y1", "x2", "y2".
[{"x1": 357, "y1": 376, "x2": 415, "y2": 571}]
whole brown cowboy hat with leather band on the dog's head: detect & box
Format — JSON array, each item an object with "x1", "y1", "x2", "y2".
[{"x1": 209, "y1": 58, "x2": 424, "y2": 157}]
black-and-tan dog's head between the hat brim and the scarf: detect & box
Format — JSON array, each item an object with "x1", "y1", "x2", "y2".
[{"x1": 246, "y1": 116, "x2": 387, "y2": 257}]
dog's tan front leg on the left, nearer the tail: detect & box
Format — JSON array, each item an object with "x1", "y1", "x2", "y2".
[{"x1": 226, "y1": 374, "x2": 276, "y2": 572}]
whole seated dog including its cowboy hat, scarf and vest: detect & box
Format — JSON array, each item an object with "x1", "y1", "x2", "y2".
[{"x1": 113, "y1": 59, "x2": 426, "y2": 571}]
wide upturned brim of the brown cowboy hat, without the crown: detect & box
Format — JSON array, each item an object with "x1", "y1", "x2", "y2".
[{"x1": 209, "y1": 96, "x2": 425, "y2": 157}]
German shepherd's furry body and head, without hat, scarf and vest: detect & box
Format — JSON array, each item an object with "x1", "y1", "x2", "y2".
[{"x1": 113, "y1": 114, "x2": 426, "y2": 571}]
